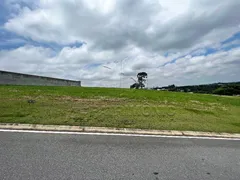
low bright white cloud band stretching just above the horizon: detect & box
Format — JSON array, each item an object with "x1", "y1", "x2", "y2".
[{"x1": 0, "y1": 46, "x2": 240, "y2": 87}]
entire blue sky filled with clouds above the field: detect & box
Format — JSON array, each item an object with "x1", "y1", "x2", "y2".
[{"x1": 0, "y1": 0, "x2": 240, "y2": 88}]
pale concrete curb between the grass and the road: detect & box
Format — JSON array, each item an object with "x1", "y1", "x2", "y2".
[{"x1": 0, "y1": 123, "x2": 240, "y2": 139}]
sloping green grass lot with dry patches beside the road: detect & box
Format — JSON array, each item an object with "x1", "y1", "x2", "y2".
[{"x1": 0, "y1": 86, "x2": 240, "y2": 133}]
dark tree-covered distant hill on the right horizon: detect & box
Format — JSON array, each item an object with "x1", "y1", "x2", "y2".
[{"x1": 152, "y1": 82, "x2": 240, "y2": 96}]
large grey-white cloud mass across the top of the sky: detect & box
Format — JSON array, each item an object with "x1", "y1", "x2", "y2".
[{"x1": 5, "y1": 0, "x2": 240, "y2": 51}]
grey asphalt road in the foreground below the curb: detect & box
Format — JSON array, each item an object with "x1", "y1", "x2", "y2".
[{"x1": 0, "y1": 132, "x2": 240, "y2": 180}]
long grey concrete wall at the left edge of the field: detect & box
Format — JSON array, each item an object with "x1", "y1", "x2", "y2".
[{"x1": 0, "y1": 71, "x2": 81, "y2": 86}]
